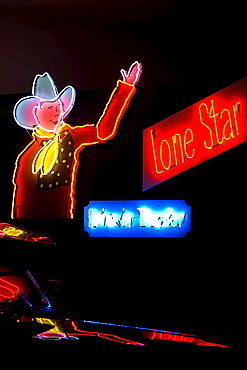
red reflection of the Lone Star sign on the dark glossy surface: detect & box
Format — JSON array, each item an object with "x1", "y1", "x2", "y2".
[{"x1": 143, "y1": 331, "x2": 230, "y2": 348}]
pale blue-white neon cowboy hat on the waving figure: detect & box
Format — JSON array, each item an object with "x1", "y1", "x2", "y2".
[{"x1": 13, "y1": 72, "x2": 75, "y2": 130}]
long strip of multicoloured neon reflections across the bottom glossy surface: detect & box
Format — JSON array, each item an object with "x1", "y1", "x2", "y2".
[{"x1": 0, "y1": 310, "x2": 247, "y2": 353}]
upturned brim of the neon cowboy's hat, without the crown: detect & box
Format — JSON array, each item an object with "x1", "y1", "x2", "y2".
[{"x1": 13, "y1": 80, "x2": 76, "y2": 130}]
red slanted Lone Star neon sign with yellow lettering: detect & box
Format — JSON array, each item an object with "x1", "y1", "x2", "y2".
[{"x1": 143, "y1": 77, "x2": 247, "y2": 190}]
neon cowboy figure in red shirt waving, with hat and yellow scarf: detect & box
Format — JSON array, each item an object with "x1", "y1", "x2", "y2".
[{"x1": 11, "y1": 62, "x2": 142, "y2": 218}]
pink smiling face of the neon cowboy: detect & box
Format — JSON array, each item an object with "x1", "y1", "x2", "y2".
[{"x1": 33, "y1": 99, "x2": 63, "y2": 132}]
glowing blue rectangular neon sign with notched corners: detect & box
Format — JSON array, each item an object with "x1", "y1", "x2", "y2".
[{"x1": 84, "y1": 200, "x2": 191, "y2": 238}]
